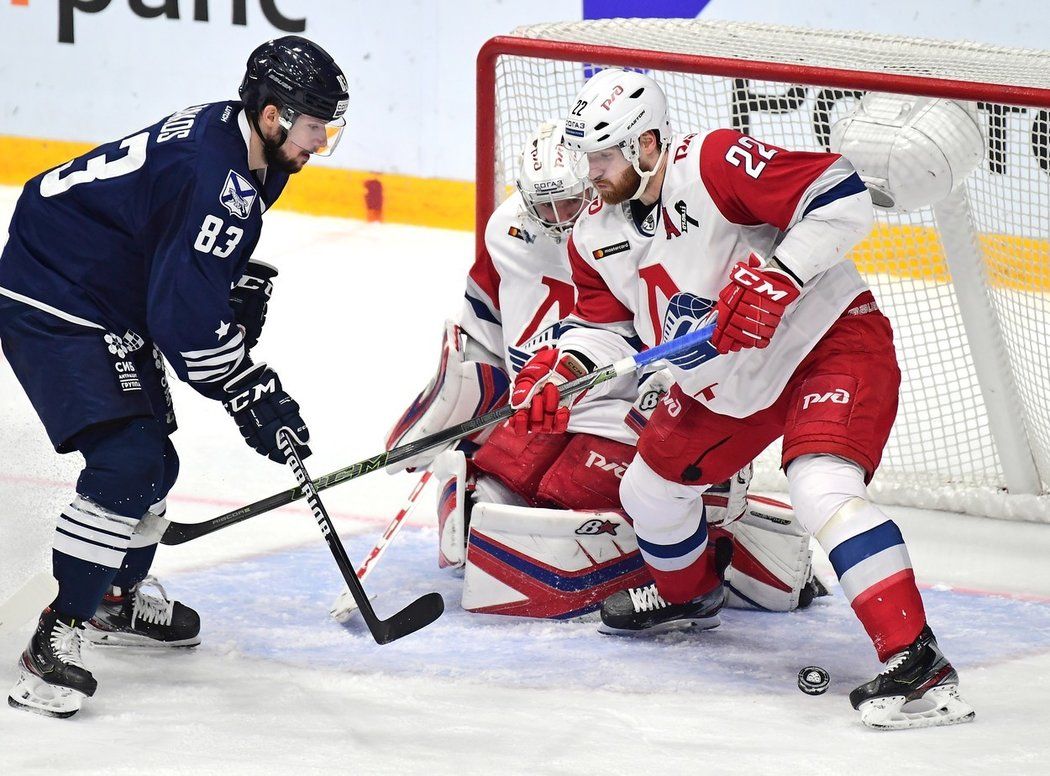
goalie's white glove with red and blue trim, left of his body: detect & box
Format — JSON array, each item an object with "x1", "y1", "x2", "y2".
[{"x1": 386, "y1": 320, "x2": 510, "y2": 474}]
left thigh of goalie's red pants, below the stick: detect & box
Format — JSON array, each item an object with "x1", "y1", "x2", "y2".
[{"x1": 473, "y1": 424, "x2": 572, "y2": 506}]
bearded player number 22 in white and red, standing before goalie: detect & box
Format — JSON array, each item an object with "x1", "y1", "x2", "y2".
[{"x1": 511, "y1": 69, "x2": 973, "y2": 727}]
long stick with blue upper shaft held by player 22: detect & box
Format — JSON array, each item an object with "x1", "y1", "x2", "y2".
[{"x1": 161, "y1": 323, "x2": 714, "y2": 544}]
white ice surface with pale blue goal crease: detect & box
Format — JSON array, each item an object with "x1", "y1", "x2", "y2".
[{"x1": 0, "y1": 189, "x2": 1050, "y2": 776}]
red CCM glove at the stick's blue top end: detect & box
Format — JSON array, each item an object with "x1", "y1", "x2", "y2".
[{"x1": 711, "y1": 253, "x2": 801, "y2": 353}]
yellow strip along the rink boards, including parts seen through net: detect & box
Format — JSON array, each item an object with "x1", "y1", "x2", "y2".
[{"x1": 0, "y1": 135, "x2": 1050, "y2": 293}]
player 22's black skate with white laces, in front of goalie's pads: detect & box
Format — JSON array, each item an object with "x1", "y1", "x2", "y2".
[{"x1": 597, "y1": 538, "x2": 733, "y2": 635}]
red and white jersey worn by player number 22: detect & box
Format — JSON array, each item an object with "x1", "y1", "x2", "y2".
[{"x1": 562, "y1": 129, "x2": 873, "y2": 417}]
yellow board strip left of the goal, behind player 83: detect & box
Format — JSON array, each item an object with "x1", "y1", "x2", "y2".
[{"x1": 0, "y1": 135, "x2": 474, "y2": 231}]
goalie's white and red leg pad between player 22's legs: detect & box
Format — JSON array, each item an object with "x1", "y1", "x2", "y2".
[{"x1": 726, "y1": 496, "x2": 813, "y2": 611}]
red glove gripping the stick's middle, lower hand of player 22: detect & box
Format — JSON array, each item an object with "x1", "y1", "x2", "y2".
[{"x1": 510, "y1": 348, "x2": 587, "y2": 435}]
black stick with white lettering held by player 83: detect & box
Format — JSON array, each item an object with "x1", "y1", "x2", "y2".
[{"x1": 277, "y1": 427, "x2": 445, "y2": 644}]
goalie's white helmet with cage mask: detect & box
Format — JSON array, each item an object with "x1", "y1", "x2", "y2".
[{"x1": 518, "y1": 121, "x2": 594, "y2": 242}]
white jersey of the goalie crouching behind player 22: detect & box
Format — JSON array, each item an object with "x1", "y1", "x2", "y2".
[{"x1": 460, "y1": 193, "x2": 637, "y2": 444}]
